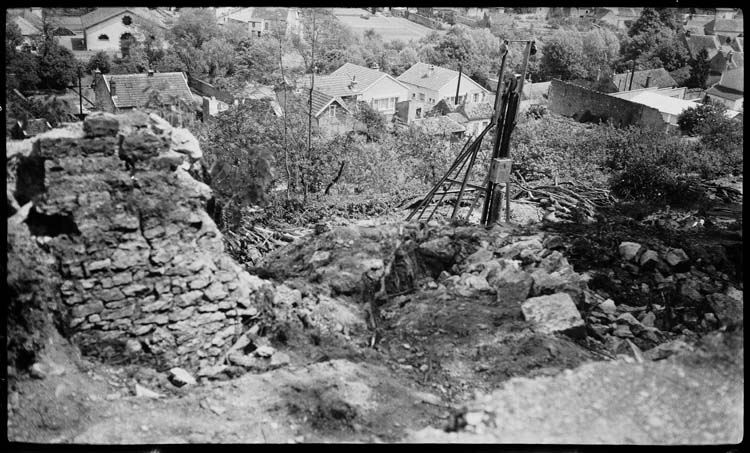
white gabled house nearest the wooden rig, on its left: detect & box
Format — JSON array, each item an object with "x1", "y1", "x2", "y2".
[{"x1": 398, "y1": 62, "x2": 490, "y2": 105}]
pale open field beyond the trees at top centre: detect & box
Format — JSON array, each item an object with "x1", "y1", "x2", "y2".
[{"x1": 333, "y1": 8, "x2": 440, "y2": 42}]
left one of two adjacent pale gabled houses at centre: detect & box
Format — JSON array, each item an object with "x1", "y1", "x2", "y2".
[{"x1": 300, "y1": 63, "x2": 409, "y2": 120}]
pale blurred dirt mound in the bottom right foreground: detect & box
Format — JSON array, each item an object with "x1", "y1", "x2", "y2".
[{"x1": 410, "y1": 326, "x2": 744, "y2": 445}]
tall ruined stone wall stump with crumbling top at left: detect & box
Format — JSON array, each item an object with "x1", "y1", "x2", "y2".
[{"x1": 26, "y1": 112, "x2": 270, "y2": 368}]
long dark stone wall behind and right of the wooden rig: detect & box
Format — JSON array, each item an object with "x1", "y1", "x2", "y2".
[{"x1": 549, "y1": 79, "x2": 667, "y2": 127}]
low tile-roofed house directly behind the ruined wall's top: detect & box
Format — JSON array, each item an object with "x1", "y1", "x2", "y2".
[{"x1": 94, "y1": 71, "x2": 194, "y2": 113}]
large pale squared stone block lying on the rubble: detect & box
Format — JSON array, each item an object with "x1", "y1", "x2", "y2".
[{"x1": 521, "y1": 293, "x2": 586, "y2": 338}]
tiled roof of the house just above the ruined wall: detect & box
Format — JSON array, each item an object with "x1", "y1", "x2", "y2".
[{"x1": 104, "y1": 72, "x2": 193, "y2": 108}]
